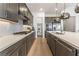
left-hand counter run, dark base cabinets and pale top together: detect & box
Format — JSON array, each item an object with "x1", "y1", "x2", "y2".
[{"x1": 0, "y1": 31, "x2": 35, "y2": 56}]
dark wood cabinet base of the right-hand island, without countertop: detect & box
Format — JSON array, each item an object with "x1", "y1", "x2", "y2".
[{"x1": 46, "y1": 32, "x2": 76, "y2": 56}]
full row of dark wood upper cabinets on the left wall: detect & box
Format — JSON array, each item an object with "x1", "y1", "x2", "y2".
[{"x1": 0, "y1": 3, "x2": 33, "y2": 23}]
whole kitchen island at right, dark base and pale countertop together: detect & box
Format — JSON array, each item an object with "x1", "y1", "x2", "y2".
[{"x1": 46, "y1": 31, "x2": 79, "y2": 56}]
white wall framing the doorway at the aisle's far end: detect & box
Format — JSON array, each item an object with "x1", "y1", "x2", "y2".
[{"x1": 33, "y1": 12, "x2": 45, "y2": 38}]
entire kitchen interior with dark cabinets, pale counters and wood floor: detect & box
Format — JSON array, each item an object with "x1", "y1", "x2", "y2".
[{"x1": 0, "y1": 3, "x2": 79, "y2": 56}]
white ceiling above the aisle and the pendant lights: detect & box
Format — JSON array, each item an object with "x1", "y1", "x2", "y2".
[{"x1": 26, "y1": 3, "x2": 76, "y2": 15}]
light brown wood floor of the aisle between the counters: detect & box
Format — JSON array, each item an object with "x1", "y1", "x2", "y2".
[{"x1": 28, "y1": 38, "x2": 52, "y2": 56}]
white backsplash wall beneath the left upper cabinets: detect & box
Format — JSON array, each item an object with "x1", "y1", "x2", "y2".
[{"x1": 0, "y1": 20, "x2": 23, "y2": 36}]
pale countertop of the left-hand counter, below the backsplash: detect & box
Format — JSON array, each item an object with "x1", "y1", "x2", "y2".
[{"x1": 0, "y1": 31, "x2": 34, "y2": 52}]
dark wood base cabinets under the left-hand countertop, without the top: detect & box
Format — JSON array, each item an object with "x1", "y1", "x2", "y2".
[{"x1": 0, "y1": 32, "x2": 35, "y2": 56}]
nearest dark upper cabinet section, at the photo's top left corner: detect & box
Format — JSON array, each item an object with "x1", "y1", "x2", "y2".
[{"x1": 0, "y1": 3, "x2": 18, "y2": 22}]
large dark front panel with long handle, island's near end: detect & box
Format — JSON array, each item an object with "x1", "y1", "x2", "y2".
[{"x1": 56, "y1": 40, "x2": 75, "y2": 56}]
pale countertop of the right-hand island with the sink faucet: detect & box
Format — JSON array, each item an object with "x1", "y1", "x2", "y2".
[{"x1": 48, "y1": 31, "x2": 79, "y2": 50}]
